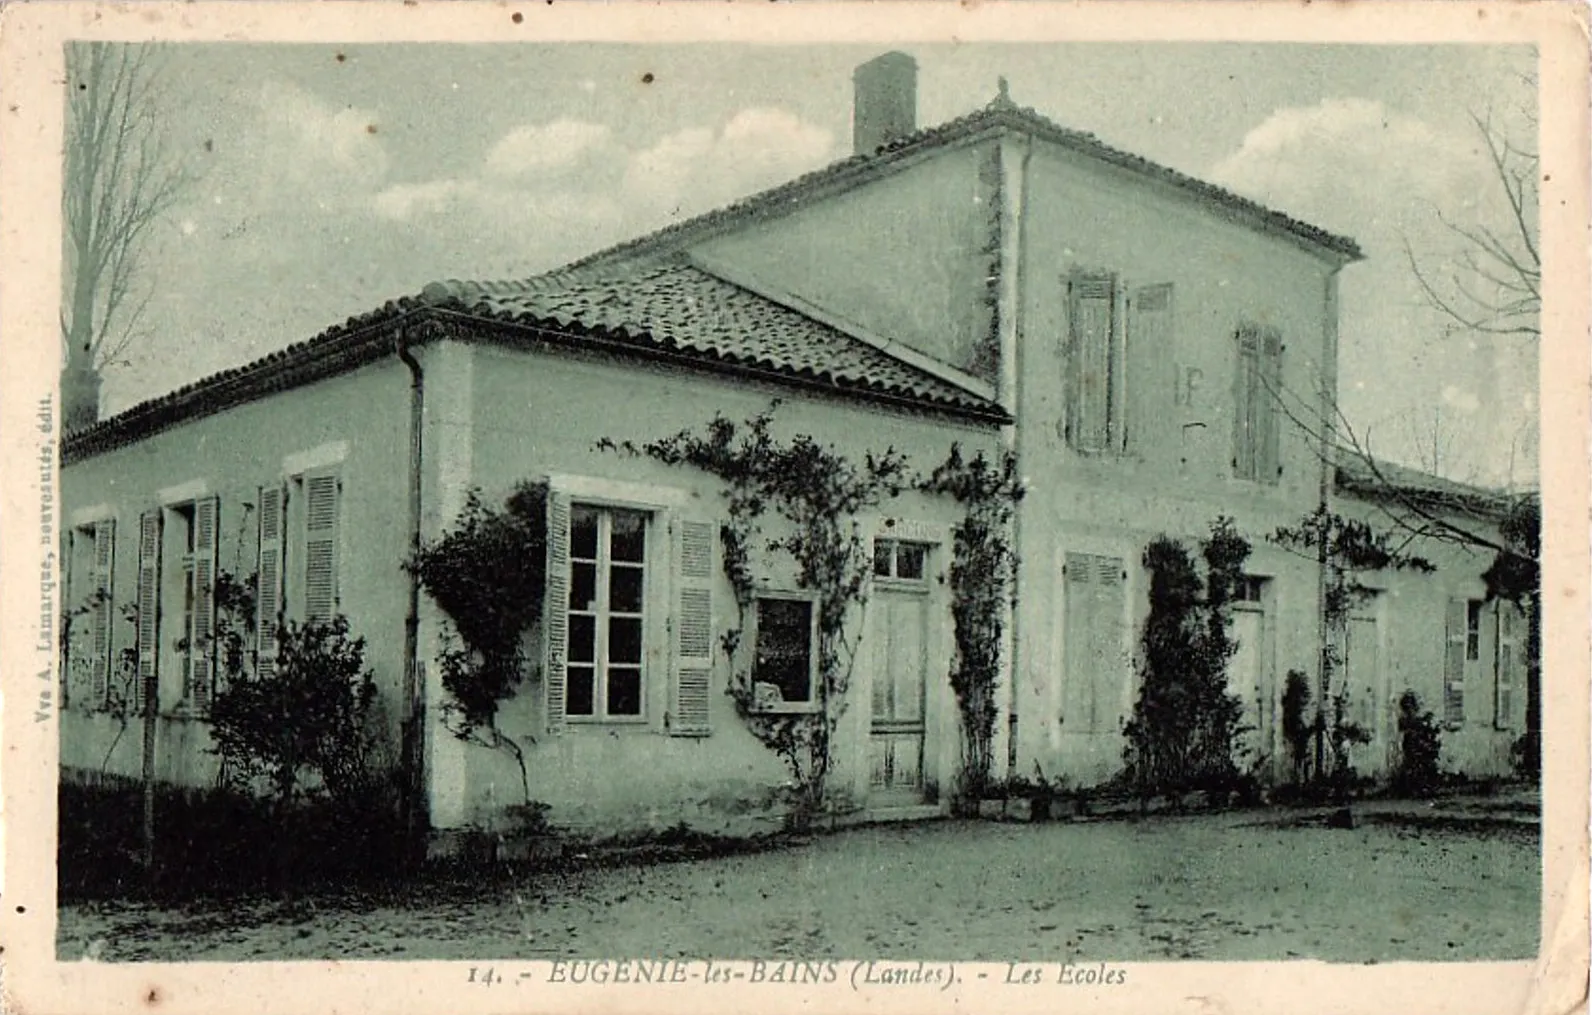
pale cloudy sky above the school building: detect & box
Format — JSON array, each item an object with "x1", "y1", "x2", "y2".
[{"x1": 93, "y1": 43, "x2": 1536, "y2": 484}]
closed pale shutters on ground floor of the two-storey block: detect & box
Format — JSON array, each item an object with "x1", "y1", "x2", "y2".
[{"x1": 1062, "y1": 554, "x2": 1127, "y2": 733}]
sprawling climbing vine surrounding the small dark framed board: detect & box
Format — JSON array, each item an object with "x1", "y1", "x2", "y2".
[{"x1": 599, "y1": 401, "x2": 907, "y2": 827}]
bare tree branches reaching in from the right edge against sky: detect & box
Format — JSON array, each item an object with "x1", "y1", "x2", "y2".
[{"x1": 1404, "y1": 78, "x2": 1543, "y2": 346}]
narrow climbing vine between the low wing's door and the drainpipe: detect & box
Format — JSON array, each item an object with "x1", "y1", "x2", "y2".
[{"x1": 917, "y1": 445, "x2": 1024, "y2": 808}]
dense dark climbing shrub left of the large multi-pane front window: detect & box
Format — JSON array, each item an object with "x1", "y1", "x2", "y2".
[{"x1": 409, "y1": 482, "x2": 548, "y2": 805}]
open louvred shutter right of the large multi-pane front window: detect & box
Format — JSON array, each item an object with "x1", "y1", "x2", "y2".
[{"x1": 665, "y1": 519, "x2": 716, "y2": 737}]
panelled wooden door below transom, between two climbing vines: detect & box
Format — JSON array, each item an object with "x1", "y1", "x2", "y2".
[{"x1": 868, "y1": 572, "x2": 930, "y2": 807}]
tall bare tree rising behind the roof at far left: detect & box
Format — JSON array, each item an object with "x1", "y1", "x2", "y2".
[{"x1": 60, "y1": 41, "x2": 191, "y2": 428}]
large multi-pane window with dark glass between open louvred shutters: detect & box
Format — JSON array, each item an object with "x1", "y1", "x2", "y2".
[{"x1": 564, "y1": 504, "x2": 648, "y2": 719}]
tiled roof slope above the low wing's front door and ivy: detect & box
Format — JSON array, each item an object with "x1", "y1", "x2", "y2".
[{"x1": 423, "y1": 259, "x2": 1006, "y2": 418}]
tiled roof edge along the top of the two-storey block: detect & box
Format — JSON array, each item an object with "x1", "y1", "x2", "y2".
[{"x1": 570, "y1": 99, "x2": 1364, "y2": 269}]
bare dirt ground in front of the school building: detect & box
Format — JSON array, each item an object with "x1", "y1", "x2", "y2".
[{"x1": 57, "y1": 800, "x2": 1539, "y2": 963}]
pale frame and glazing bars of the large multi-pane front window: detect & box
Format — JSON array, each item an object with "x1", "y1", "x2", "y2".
[{"x1": 564, "y1": 493, "x2": 655, "y2": 725}]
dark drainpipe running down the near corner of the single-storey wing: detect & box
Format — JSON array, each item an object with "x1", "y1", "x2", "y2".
[{"x1": 393, "y1": 325, "x2": 425, "y2": 858}]
